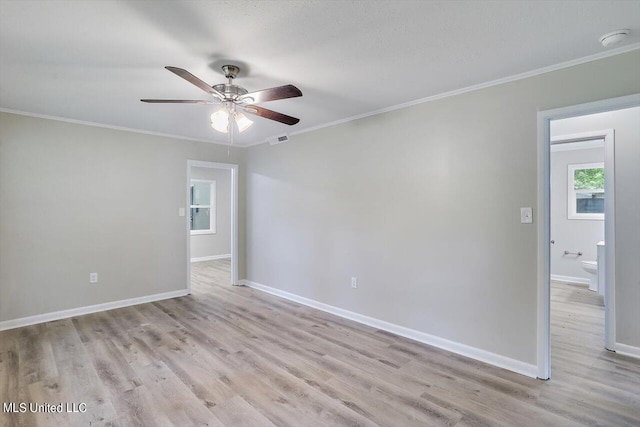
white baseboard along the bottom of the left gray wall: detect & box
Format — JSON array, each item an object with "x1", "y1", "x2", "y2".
[{"x1": 0, "y1": 289, "x2": 189, "y2": 331}]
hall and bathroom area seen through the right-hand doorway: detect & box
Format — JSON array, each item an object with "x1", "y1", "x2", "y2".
[{"x1": 549, "y1": 106, "x2": 640, "y2": 359}]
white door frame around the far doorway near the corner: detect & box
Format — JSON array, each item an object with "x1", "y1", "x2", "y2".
[{"x1": 185, "y1": 160, "x2": 238, "y2": 294}]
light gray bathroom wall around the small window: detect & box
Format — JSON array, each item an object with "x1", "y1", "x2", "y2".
[{"x1": 550, "y1": 147, "x2": 604, "y2": 281}]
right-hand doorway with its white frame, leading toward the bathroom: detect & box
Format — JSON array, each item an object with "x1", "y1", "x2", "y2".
[{"x1": 538, "y1": 95, "x2": 640, "y2": 379}]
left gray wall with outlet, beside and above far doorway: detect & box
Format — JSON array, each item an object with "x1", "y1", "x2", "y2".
[{"x1": 0, "y1": 113, "x2": 244, "y2": 320}]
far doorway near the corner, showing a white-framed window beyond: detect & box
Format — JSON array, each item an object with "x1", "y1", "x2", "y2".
[{"x1": 185, "y1": 160, "x2": 238, "y2": 293}]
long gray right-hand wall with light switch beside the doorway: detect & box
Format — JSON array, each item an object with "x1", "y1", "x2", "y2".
[{"x1": 246, "y1": 50, "x2": 640, "y2": 364}]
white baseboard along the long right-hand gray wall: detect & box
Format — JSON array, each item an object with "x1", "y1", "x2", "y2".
[{"x1": 240, "y1": 280, "x2": 538, "y2": 378}]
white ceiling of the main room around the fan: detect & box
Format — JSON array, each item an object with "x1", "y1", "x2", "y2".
[{"x1": 0, "y1": 0, "x2": 640, "y2": 145}]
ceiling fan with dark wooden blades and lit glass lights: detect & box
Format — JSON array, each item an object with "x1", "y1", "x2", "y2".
[{"x1": 140, "y1": 65, "x2": 302, "y2": 135}]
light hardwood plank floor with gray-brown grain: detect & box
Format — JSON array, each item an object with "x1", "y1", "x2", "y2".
[{"x1": 0, "y1": 261, "x2": 640, "y2": 427}]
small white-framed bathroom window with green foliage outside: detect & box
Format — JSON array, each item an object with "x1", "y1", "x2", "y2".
[{"x1": 567, "y1": 163, "x2": 604, "y2": 220}]
